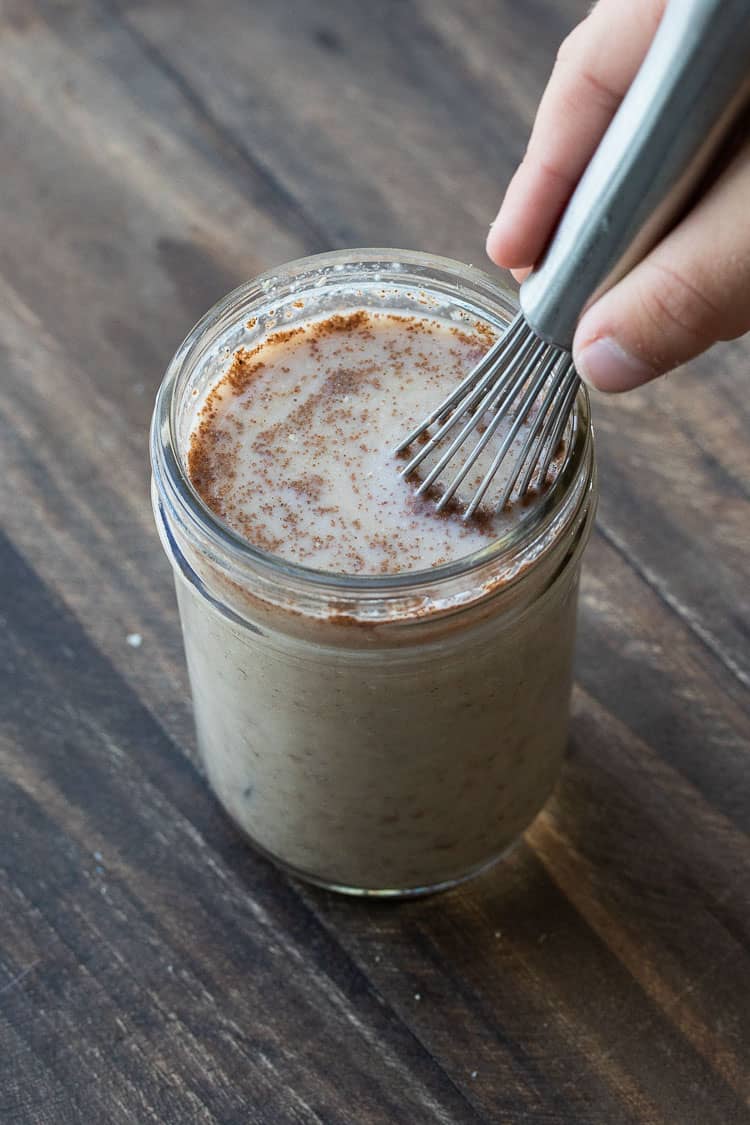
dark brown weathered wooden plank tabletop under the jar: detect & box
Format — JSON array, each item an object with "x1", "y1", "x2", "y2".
[{"x1": 0, "y1": 0, "x2": 750, "y2": 1125}]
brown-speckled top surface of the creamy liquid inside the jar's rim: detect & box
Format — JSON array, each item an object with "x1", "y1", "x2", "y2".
[{"x1": 188, "y1": 309, "x2": 557, "y2": 574}]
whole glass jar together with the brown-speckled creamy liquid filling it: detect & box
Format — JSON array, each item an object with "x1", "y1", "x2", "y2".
[{"x1": 152, "y1": 250, "x2": 594, "y2": 896}]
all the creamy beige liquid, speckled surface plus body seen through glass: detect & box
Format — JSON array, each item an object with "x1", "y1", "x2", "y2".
[{"x1": 168, "y1": 311, "x2": 578, "y2": 893}]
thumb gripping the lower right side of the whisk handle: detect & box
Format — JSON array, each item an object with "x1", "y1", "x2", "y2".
[{"x1": 573, "y1": 142, "x2": 750, "y2": 392}]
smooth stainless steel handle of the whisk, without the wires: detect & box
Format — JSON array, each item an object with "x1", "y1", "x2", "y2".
[{"x1": 521, "y1": 0, "x2": 750, "y2": 351}]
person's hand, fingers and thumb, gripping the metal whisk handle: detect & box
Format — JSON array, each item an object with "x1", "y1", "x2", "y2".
[{"x1": 487, "y1": 0, "x2": 750, "y2": 392}]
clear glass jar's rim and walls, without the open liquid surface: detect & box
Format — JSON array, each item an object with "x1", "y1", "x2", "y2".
[{"x1": 151, "y1": 250, "x2": 596, "y2": 896}]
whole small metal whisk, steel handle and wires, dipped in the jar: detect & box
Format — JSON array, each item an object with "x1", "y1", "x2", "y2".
[{"x1": 395, "y1": 0, "x2": 750, "y2": 519}]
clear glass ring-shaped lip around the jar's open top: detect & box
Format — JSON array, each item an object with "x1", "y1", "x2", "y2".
[{"x1": 151, "y1": 246, "x2": 591, "y2": 596}]
